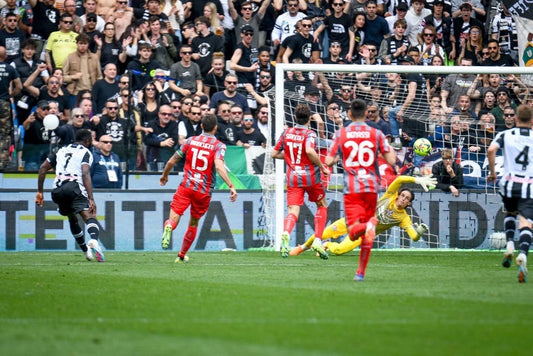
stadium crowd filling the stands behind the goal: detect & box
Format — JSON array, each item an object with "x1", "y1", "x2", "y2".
[{"x1": 0, "y1": 0, "x2": 532, "y2": 178}]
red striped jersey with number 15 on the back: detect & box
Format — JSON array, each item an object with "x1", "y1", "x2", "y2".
[{"x1": 176, "y1": 133, "x2": 226, "y2": 194}]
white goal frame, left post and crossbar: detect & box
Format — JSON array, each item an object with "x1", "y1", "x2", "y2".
[{"x1": 260, "y1": 63, "x2": 533, "y2": 250}]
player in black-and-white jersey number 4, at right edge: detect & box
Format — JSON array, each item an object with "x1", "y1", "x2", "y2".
[{"x1": 487, "y1": 105, "x2": 533, "y2": 283}]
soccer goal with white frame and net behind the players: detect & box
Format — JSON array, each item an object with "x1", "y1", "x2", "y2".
[{"x1": 254, "y1": 63, "x2": 533, "y2": 250}]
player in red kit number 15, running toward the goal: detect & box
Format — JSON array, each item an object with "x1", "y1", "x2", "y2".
[{"x1": 159, "y1": 112, "x2": 237, "y2": 263}]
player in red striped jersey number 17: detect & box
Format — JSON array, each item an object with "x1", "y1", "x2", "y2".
[{"x1": 272, "y1": 104, "x2": 329, "y2": 259}]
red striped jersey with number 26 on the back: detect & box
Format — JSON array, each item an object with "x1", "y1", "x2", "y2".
[{"x1": 329, "y1": 122, "x2": 391, "y2": 194}]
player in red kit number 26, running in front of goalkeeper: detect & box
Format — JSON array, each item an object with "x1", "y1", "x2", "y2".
[{"x1": 326, "y1": 99, "x2": 396, "y2": 281}]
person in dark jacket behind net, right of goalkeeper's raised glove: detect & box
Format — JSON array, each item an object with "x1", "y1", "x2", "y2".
[{"x1": 431, "y1": 149, "x2": 463, "y2": 197}]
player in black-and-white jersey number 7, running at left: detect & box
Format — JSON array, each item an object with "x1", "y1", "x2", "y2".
[{"x1": 35, "y1": 129, "x2": 104, "y2": 262}]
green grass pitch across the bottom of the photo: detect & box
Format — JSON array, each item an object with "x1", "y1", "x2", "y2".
[{"x1": 0, "y1": 251, "x2": 533, "y2": 356}]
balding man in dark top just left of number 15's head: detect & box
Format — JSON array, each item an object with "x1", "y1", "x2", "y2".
[{"x1": 144, "y1": 105, "x2": 179, "y2": 171}]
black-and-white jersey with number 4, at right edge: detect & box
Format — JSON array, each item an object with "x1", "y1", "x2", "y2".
[{"x1": 493, "y1": 127, "x2": 533, "y2": 199}]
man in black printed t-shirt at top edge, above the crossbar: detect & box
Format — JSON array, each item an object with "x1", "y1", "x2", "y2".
[{"x1": 313, "y1": 0, "x2": 355, "y2": 58}]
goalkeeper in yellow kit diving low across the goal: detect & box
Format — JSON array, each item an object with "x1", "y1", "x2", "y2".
[{"x1": 289, "y1": 176, "x2": 437, "y2": 256}]
